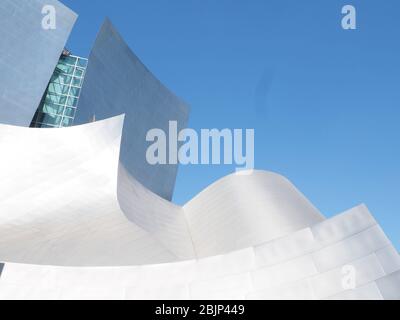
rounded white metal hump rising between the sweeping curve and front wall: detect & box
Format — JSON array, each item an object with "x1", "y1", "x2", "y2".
[{"x1": 183, "y1": 171, "x2": 324, "y2": 257}]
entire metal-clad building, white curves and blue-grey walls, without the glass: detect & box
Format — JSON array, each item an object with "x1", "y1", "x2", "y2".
[{"x1": 0, "y1": 0, "x2": 400, "y2": 300}]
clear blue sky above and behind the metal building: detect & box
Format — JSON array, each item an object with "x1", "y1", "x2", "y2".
[{"x1": 62, "y1": 0, "x2": 400, "y2": 249}]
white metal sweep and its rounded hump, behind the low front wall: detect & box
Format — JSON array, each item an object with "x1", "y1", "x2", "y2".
[{"x1": 0, "y1": 116, "x2": 323, "y2": 266}]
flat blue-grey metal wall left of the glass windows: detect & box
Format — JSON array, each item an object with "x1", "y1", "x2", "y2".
[{"x1": 0, "y1": 0, "x2": 77, "y2": 127}]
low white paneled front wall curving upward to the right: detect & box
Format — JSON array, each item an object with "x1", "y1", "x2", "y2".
[{"x1": 0, "y1": 206, "x2": 400, "y2": 300}]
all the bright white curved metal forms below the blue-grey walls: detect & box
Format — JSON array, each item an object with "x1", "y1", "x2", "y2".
[{"x1": 0, "y1": 116, "x2": 400, "y2": 299}]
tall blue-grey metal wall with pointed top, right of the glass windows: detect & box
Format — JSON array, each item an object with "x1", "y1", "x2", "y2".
[{"x1": 75, "y1": 20, "x2": 189, "y2": 200}]
